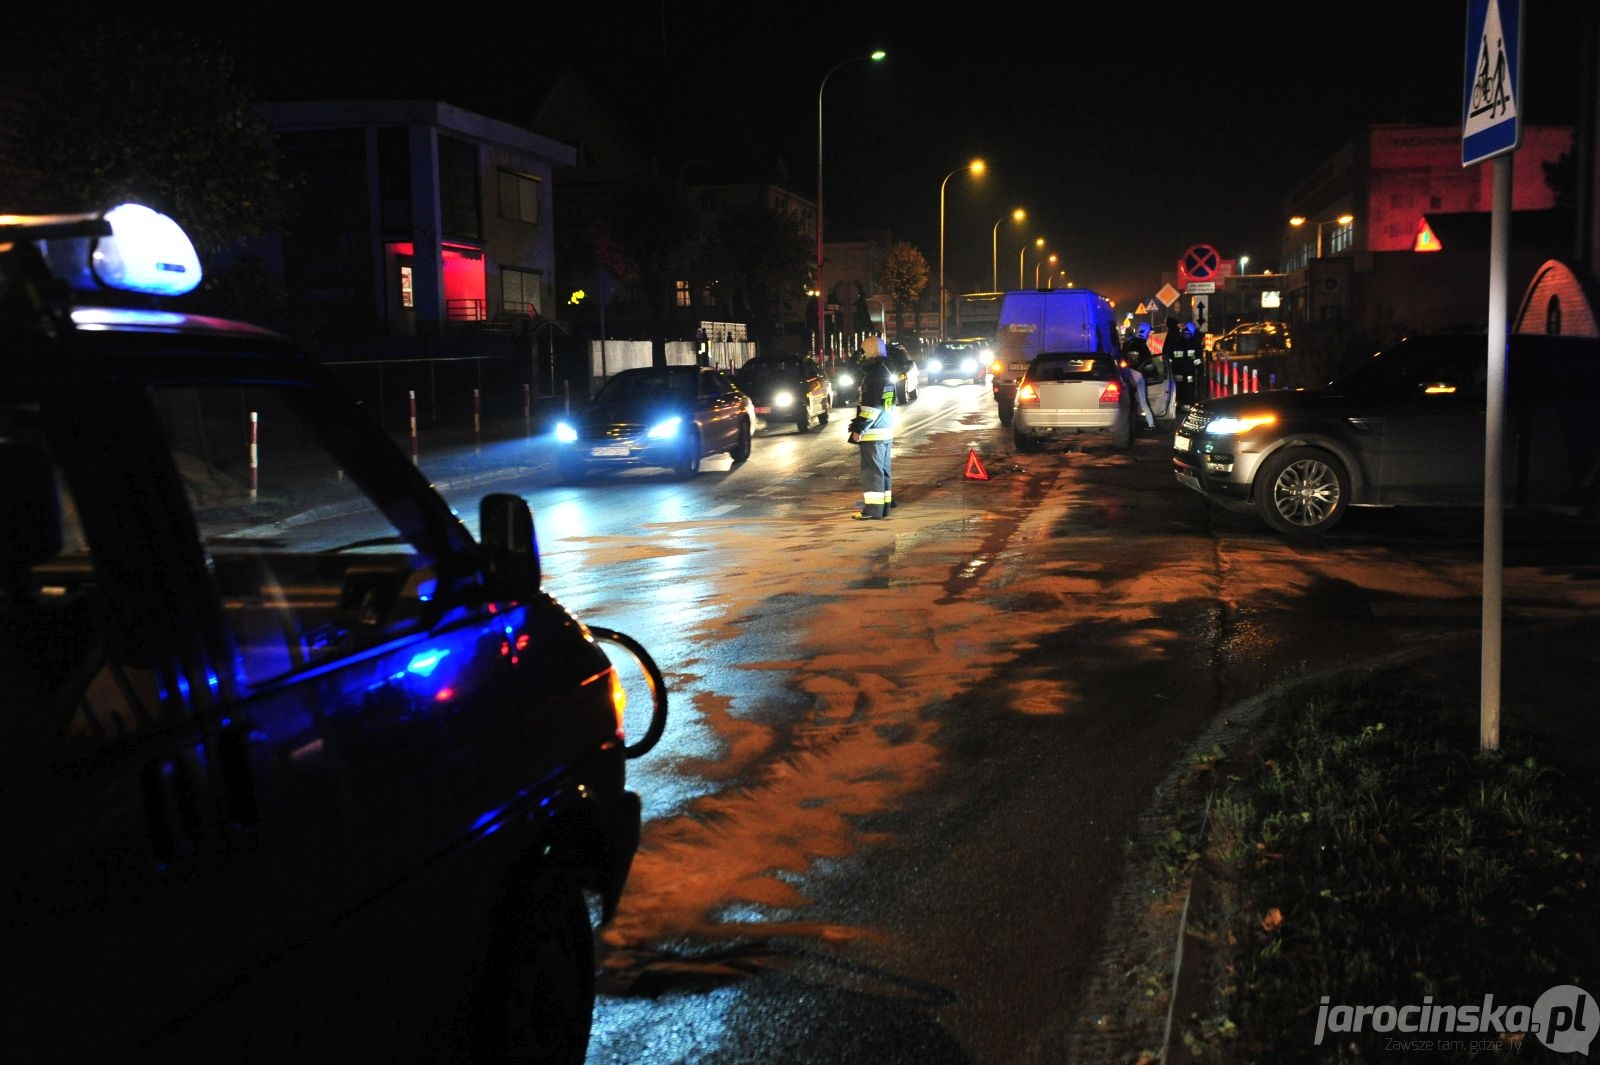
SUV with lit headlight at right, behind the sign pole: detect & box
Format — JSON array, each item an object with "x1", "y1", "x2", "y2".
[{"x1": 1173, "y1": 333, "x2": 1600, "y2": 537}]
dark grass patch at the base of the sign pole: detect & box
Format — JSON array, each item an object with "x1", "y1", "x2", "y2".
[{"x1": 1163, "y1": 676, "x2": 1600, "y2": 1062}]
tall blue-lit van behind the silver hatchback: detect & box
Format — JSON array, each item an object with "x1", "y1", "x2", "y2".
[{"x1": 990, "y1": 288, "x2": 1122, "y2": 425}]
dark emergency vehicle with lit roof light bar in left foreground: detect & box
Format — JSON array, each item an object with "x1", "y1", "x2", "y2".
[{"x1": 0, "y1": 205, "x2": 666, "y2": 1063}]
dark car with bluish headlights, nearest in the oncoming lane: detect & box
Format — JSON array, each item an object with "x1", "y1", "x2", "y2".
[{"x1": 555, "y1": 366, "x2": 755, "y2": 481}]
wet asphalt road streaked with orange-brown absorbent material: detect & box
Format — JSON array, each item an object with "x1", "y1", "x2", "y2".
[{"x1": 419, "y1": 387, "x2": 1594, "y2": 1065}]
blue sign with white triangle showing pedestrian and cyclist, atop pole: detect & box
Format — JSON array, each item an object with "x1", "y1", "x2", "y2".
[{"x1": 1461, "y1": 0, "x2": 1523, "y2": 166}]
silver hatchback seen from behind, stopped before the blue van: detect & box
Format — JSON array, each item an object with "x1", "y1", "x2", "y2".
[{"x1": 1011, "y1": 352, "x2": 1133, "y2": 451}]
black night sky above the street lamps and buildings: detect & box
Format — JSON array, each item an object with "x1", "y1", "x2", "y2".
[{"x1": 59, "y1": 0, "x2": 1595, "y2": 301}]
